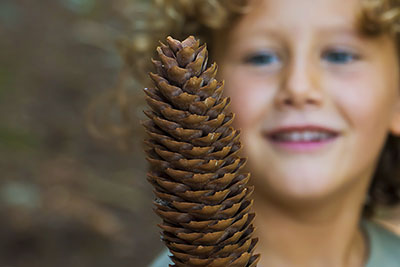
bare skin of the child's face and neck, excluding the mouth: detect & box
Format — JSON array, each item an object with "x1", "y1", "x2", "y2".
[{"x1": 215, "y1": 0, "x2": 400, "y2": 267}]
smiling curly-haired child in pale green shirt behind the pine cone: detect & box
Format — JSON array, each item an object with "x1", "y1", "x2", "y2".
[{"x1": 133, "y1": 0, "x2": 400, "y2": 267}]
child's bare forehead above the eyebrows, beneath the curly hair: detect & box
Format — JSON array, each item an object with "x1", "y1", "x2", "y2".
[{"x1": 241, "y1": 0, "x2": 361, "y2": 37}]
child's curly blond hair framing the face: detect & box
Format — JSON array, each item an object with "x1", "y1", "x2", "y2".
[{"x1": 89, "y1": 0, "x2": 400, "y2": 217}]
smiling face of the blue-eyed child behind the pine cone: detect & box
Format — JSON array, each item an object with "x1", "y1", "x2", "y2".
[{"x1": 217, "y1": 0, "x2": 400, "y2": 200}]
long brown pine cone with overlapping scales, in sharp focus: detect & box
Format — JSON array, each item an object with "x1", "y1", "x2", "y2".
[{"x1": 143, "y1": 36, "x2": 259, "y2": 267}]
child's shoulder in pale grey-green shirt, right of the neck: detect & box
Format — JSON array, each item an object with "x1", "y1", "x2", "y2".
[{"x1": 362, "y1": 221, "x2": 400, "y2": 267}]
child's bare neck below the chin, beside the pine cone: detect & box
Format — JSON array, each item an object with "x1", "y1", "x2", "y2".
[{"x1": 254, "y1": 177, "x2": 368, "y2": 267}]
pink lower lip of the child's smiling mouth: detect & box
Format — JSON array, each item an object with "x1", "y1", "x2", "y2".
[{"x1": 268, "y1": 136, "x2": 337, "y2": 152}]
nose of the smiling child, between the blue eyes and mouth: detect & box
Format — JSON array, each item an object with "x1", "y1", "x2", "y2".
[{"x1": 275, "y1": 58, "x2": 323, "y2": 109}]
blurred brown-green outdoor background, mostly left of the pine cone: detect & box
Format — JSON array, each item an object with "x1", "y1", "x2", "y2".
[{"x1": 0, "y1": 0, "x2": 400, "y2": 267}]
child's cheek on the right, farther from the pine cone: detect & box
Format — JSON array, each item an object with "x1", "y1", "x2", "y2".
[{"x1": 329, "y1": 72, "x2": 395, "y2": 177}]
